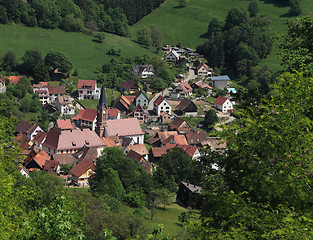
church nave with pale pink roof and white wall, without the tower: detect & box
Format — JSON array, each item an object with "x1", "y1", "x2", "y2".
[{"x1": 104, "y1": 118, "x2": 144, "y2": 144}]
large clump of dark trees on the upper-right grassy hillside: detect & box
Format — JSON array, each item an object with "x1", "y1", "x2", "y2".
[{"x1": 197, "y1": 5, "x2": 272, "y2": 77}]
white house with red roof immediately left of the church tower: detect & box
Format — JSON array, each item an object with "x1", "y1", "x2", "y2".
[{"x1": 73, "y1": 108, "x2": 97, "y2": 131}]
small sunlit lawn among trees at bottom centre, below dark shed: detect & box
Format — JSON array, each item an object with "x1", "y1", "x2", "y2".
[{"x1": 144, "y1": 204, "x2": 188, "y2": 236}]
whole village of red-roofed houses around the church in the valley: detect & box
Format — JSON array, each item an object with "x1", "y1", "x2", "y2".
[{"x1": 9, "y1": 46, "x2": 236, "y2": 205}]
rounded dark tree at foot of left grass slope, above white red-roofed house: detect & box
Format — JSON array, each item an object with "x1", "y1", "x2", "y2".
[{"x1": 44, "y1": 52, "x2": 73, "y2": 74}]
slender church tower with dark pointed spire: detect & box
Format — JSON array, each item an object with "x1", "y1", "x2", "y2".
[{"x1": 96, "y1": 85, "x2": 108, "y2": 137}]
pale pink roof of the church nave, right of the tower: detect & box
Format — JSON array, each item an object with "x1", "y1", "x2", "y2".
[{"x1": 106, "y1": 118, "x2": 144, "y2": 137}]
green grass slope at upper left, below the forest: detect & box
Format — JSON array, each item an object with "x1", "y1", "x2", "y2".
[{"x1": 0, "y1": 25, "x2": 155, "y2": 79}]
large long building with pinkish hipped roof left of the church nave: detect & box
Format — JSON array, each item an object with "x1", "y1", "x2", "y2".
[{"x1": 42, "y1": 127, "x2": 105, "y2": 156}]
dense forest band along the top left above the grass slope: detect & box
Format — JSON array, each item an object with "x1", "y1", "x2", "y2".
[{"x1": 0, "y1": 0, "x2": 163, "y2": 36}]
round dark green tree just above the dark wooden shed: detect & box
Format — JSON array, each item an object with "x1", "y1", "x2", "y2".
[{"x1": 159, "y1": 148, "x2": 193, "y2": 183}]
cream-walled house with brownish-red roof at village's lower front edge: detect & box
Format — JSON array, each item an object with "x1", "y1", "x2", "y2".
[{"x1": 70, "y1": 158, "x2": 96, "y2": 187}]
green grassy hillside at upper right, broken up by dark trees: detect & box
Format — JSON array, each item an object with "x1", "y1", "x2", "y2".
[{"x1": 132, "y1": 0, "x2": 313, "y2": 71}]
